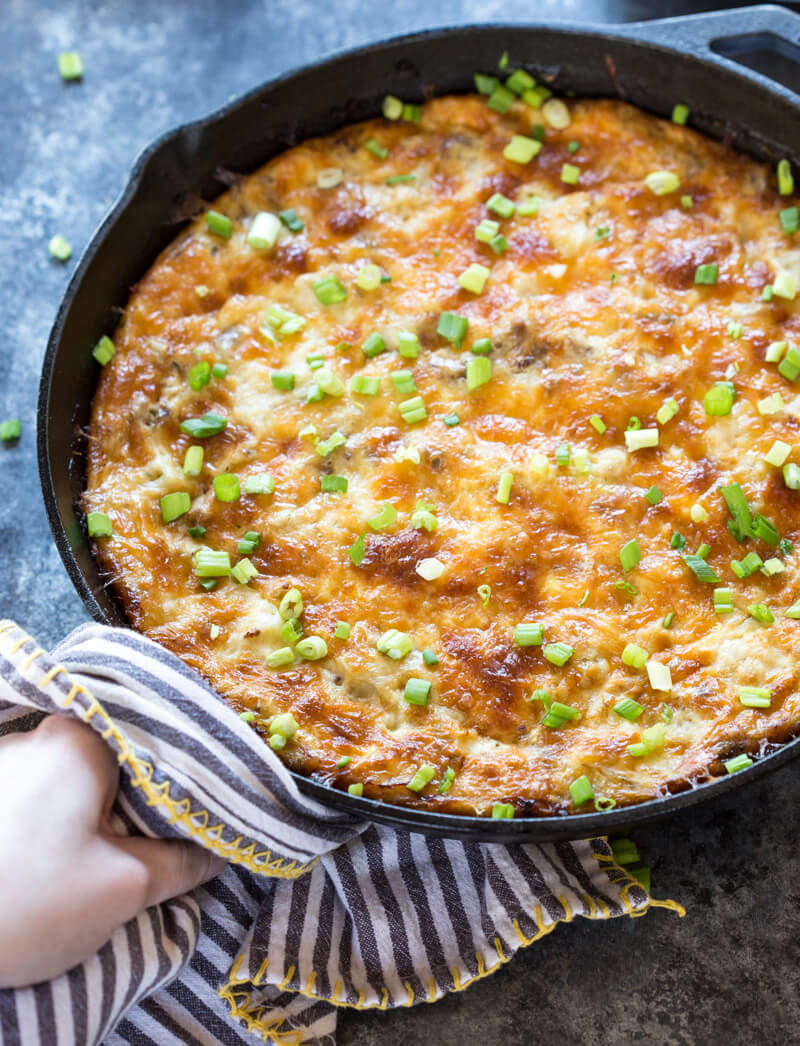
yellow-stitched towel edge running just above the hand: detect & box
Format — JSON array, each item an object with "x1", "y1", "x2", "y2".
[{"x1": 0, "y1": 621, "x2": 317, "y2": 882}]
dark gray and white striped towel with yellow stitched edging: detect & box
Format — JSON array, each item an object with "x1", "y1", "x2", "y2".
[{"x1": 0, "y1": 621, "x2": 677, "y2": 1046}]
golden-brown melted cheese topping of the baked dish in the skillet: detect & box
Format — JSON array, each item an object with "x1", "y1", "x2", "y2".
[{"x1": 85, "y1": 97, "x2": 800, "y2": 815}]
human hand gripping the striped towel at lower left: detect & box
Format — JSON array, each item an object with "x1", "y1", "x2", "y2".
[{"x1": 0, "y1": 715, "x2": 225, "y2": 987}]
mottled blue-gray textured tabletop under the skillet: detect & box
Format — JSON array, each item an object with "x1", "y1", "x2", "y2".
[{"x1": 0, "y1": 0, "x2": 800, "y2": 1046}]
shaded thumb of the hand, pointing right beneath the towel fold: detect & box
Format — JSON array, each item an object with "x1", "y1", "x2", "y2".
[{"x1": 114, "y1": 836, "x2": 227, "y2": 908}]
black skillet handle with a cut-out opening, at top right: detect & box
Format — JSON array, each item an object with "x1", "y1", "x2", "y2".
[{"x1": 619, "y1": 4, "x2": 800, "y2": 103}]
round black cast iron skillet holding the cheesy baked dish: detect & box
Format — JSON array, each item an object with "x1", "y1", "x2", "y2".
[{"x1": 39, "y1": 6, "x2": 800, "y2": 842}]
